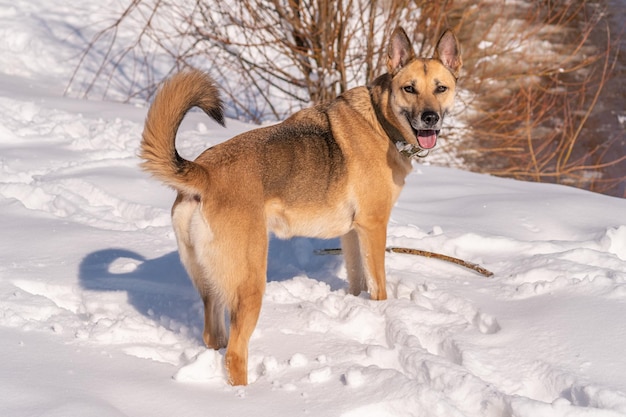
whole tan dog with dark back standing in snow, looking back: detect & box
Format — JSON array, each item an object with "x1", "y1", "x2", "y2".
[{"x1": 140, "y1": 27, "x2": 462, "y2": 385}]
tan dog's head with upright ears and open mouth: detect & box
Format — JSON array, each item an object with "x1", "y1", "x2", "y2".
[{"x1": 380, "y1": 27, "x2": 462, "y2": 149}]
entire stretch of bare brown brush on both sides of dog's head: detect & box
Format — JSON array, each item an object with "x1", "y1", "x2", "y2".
[{"x1": 70, "y1": 0, "x2": 626, "y2": 195}]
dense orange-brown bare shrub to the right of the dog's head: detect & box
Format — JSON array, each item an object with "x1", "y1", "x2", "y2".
[{"x1": 460, "y1": 1, "x2": 626, "y2": 192}]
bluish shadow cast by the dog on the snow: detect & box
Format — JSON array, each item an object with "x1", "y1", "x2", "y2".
[{"x1": 79, "y1": 238, "x2": 346, "y2": 335}]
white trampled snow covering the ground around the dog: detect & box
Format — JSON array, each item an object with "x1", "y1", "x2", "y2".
[{"x1": 0, "y1": 0, "x2": 626, "y2": 417}]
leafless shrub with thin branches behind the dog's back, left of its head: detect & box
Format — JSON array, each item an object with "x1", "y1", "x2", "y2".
[{"x1": 68, "y1": 0, "x2": 445, "y2": 122}]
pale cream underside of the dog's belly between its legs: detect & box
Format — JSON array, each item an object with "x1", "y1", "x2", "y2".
[{"x1": 265, "y1": 200, "x2": 354, "y2": 239}]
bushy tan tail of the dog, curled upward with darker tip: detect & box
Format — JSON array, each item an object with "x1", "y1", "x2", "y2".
[{"x1": 139, "y1": 70, "x2": 224, "y2": 194}]
